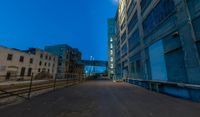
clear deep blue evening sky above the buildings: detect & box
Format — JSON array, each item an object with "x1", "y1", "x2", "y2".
[{"x1": 0, "y1": 0, "x2": 117, "y2": 60}]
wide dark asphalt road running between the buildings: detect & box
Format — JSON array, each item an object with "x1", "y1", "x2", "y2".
[{"x1": 0, "y1": 77, "x2": 200, "y2": 117}]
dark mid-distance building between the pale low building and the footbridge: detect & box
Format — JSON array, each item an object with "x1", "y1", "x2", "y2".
[{"x1": 45, "y1": 44, "x2": 84, "y2": 79}]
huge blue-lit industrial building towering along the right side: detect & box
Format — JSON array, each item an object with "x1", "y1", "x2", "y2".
[{"x1": 115, "y1": 0, "x2": 200, "y2": 100}]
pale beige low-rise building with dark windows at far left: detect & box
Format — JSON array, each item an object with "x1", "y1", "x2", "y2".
[{"x1": 0, "y1": 46, "x2": 58, "y2": 81}]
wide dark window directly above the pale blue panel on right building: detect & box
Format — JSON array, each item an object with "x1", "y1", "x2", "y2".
[{"x1": 143, "y1": 0, "x2": 175, "y2": 35}]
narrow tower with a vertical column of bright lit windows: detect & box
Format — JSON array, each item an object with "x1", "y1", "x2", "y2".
[{"x1": 107, "y1": 18, "x2": 115, "y2": 78}]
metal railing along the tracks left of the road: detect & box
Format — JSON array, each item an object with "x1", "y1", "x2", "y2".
[{"x1": 0, "y1": 74, "x2": 86, "y2": 99}]
